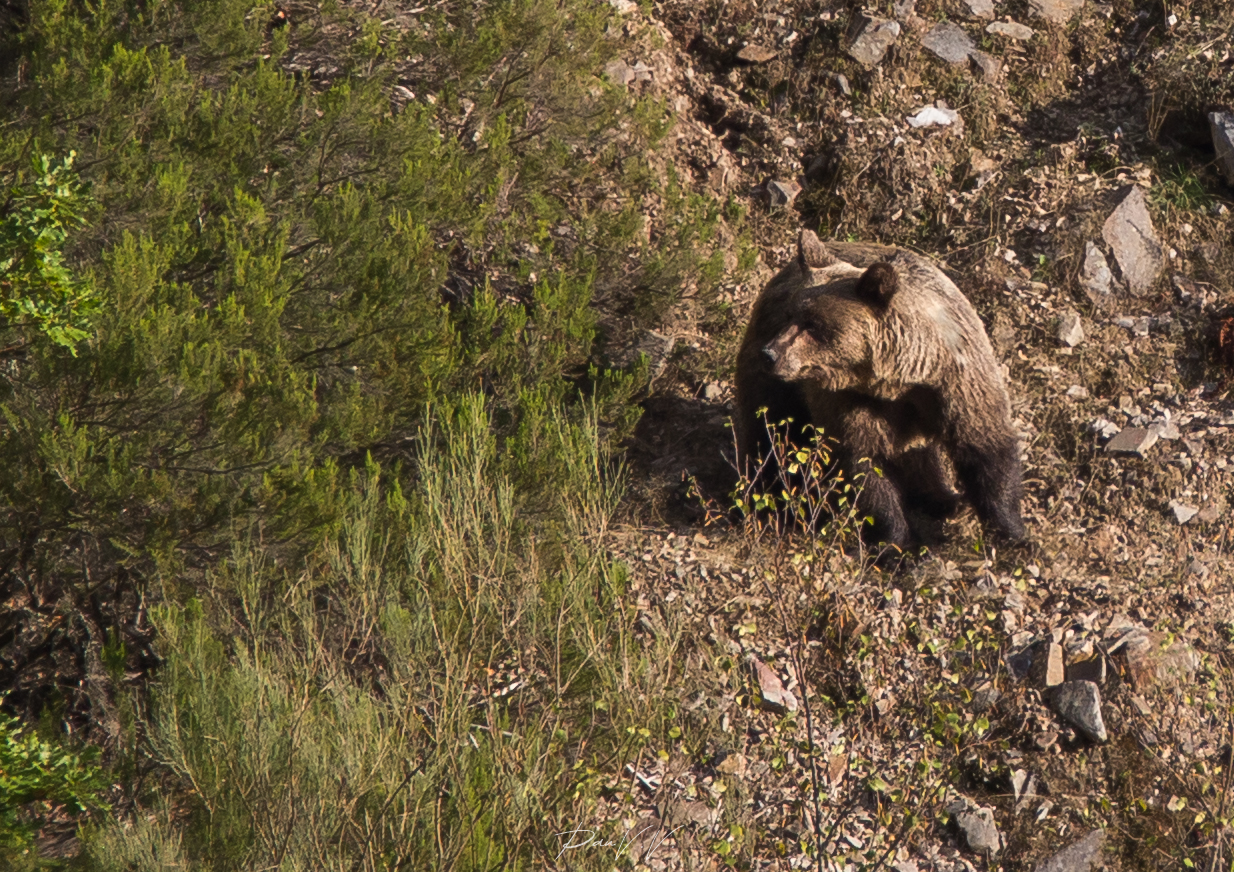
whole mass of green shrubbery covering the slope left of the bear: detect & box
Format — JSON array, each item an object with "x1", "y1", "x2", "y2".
[{"x1": 0, "y1": 0, "x2": 722, "y2": 870}]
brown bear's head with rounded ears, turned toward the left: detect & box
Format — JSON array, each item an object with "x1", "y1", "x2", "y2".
[{"x1": 763, "y1": 231, "x2": 900, "y2": 391}]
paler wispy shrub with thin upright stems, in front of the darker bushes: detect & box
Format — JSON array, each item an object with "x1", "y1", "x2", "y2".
[{"x1": 89, "y1": 397, "x2": 647, "y2": 870}]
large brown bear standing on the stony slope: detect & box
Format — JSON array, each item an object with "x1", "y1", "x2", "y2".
[{"x1": 733, "y1": 231, "x2": 1024, "y2": 548}]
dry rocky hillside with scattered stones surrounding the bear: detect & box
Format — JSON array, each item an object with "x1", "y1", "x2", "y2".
[{"x1": 610, "y1": 0, "x2": 1234, "y2": 872}]
